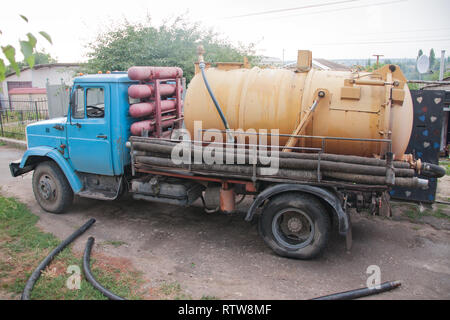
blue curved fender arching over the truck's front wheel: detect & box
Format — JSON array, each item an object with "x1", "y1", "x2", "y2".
[{"x1": 19, "y1": 146, "x2": 83, "y2": 193}]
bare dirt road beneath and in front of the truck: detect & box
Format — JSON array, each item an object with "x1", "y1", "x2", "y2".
[{"x1": 0, "y1": 147, "x2": 450, "y2": 299}]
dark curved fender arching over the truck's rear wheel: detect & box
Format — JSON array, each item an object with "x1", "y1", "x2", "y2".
[{"x1": 245, "y1": 184, "x2": 349, "y2": 236}]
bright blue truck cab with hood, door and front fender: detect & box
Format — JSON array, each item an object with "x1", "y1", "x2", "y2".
[{"x1": 10, "y1": 72, "x2": 136, "y2": 212}]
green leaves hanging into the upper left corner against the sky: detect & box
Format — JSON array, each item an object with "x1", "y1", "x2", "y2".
[{"x1": 0, "y1": 15, "x2": 52, "y2": 82}]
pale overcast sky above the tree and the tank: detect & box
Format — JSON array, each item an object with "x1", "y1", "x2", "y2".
[{"x1": 0, "y1": 0, "x2": 450, "y2": 62}]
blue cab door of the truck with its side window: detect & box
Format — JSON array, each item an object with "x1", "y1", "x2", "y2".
[{"x1": 67, "y1": 85, "x2": 114, "y2": 176}]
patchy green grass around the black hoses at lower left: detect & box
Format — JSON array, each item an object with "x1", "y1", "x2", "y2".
[{"x1": 0, "y1": 196, "x2": 142, "y2": 300}]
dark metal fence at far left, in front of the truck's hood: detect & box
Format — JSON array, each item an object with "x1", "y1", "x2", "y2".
[{"x1": 0, "y1": 99, "x2": 49, "y2": 140}]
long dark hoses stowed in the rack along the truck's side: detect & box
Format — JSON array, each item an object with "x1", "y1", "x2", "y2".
[{"x1": 130, "y1": 137, "x2": 427, "y2": 188}]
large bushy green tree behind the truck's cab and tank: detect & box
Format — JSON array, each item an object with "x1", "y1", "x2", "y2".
[{"x1": 84, "y1": 17, "x2": 257, "y2": 81}]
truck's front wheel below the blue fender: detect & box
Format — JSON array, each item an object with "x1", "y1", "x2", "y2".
[{"x1": 33, "y1": 161, "x2": 73, "y2": 213}]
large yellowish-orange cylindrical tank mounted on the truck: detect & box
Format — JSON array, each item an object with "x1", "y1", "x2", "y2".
[{"x1": 184, "y1": 57, "x2": 413, "y2": 159}]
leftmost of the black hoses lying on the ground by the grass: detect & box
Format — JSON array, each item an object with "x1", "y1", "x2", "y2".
[{"x1": 21, "y1": 219, "x2": 95, "y2": 300}]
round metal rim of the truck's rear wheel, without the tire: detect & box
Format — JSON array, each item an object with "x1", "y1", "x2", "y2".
[{"x1": 272, "y1": 208, "x2": 315, "y2": 250}]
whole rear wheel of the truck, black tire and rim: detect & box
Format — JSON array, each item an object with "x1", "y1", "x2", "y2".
[{"x1": 258, "y1": 192, "x2": 331, "y2": 260}]
